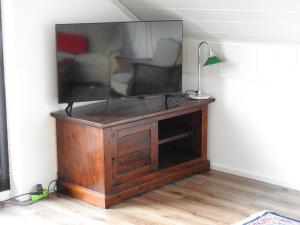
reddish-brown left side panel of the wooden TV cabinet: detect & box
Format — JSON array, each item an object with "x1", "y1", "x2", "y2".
[{"x1": 56, "y1": 120, "x2": 105, "y2": 193}]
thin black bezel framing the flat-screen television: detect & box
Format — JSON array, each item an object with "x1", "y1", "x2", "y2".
[{"x1": 55, "y1": 19, "x2": 183, "y2": 104}]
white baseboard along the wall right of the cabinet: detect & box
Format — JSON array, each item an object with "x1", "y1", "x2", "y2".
[{"x1": 210, "y1": 163, "x2": 300, "y2": 191}]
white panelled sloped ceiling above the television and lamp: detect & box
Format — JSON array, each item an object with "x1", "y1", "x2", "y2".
[{"x1": 120, "y1": 0, "x2": 300, "y2": 43}]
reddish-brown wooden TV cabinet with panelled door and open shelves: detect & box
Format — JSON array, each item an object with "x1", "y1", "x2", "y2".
[{"x1": 51, "y1": 96, "x2": 214, "y2": 208}]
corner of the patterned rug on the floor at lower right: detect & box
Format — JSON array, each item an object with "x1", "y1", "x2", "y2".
[{"x1": 233, "y1": 211, "x2": 300, "y2": 225}]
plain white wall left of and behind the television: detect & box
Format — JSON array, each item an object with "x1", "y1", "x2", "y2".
[{"x1": 2, "y1": 0, "x2": 129, "y2": 197}]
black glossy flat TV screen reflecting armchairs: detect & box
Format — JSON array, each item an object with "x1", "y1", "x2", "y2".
[{"x1": 56, "y1": 20, "x2": 183, "y2": 103}]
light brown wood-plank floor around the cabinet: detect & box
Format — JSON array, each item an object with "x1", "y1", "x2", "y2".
[{"x1": 0, "y1": 171, "x2": 300, "y2": 225}]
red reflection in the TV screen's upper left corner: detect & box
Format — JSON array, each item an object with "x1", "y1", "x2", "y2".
[{"x1": 56, "y1": 32, "x2": 87, "y2": 54}]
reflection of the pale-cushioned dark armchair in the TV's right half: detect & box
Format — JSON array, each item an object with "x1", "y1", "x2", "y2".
[{"x1": 111, "y1": 39, "x2": 181, "y2": 95}]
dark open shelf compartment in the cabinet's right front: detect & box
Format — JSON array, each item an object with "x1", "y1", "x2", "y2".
[{"x1": 158, "y1": 111, "x2": 201, "y2": 169}]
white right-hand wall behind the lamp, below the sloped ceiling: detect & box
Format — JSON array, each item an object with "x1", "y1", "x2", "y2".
[{"x1": 183, "y1": 39, "x2": 300, "y2": 190}]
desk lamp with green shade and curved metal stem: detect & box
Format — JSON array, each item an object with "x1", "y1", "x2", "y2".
[{"x1": 189, "y1": 41, "x2": 223, "y2": 100}]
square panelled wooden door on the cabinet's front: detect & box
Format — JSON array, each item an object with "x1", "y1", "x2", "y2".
[{"x1": 111, "y1": 122, "x2": 157, "y2": 185}]
